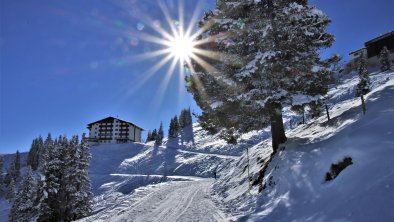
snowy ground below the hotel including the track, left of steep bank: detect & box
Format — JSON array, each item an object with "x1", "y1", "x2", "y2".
[{"x1": 82, "y1": 125, "x2": 241, "y2": 221}]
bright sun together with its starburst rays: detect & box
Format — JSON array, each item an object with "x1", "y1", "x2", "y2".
[{"x1": 120, "y1": 0, "x2": 222, "y2": 100}]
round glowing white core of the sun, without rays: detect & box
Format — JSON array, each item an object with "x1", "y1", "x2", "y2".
[{"x1": 168, "y1": 35, "x2": 195, "y2": 61}]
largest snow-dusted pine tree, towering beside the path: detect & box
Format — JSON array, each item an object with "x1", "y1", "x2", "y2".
[{"x1": 188, "y1": 0, "x2": 334, "y2": 151}]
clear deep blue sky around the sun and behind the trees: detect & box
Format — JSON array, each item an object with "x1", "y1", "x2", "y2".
[{"x1": 0, "y1": 0, "x2": 394, "y2": 153}]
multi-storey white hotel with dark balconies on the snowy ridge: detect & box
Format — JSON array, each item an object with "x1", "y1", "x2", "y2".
[{"x1": 87, "y1": 116, "x2": 144, "y2": 143}]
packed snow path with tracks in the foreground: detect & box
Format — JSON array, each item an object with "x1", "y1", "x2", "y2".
[{"x1": 81, "y1": 179, "x2": 227, "y2": 222}]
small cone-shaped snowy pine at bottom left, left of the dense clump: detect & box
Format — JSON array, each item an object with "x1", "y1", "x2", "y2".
[{"x1": 9, "y1": 167, "x2": 35, "y2": 222}]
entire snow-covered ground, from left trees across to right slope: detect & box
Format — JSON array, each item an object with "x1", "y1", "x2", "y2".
[{"x1": 0, "y1": 72, "x2": 394, "y2": 221}]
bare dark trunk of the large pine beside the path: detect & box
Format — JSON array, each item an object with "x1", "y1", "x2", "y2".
[{"x1": 270, "y1": 103, "x2": 287, "y2": 153}]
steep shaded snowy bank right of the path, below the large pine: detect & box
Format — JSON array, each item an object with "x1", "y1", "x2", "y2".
[{"x1": 213, "y1": 73, "x2": 394, "y2": 221}]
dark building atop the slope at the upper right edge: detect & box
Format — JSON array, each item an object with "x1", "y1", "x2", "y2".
[{"x1": 349, "y1": 31, "x2": 394, "y2": 66}]
